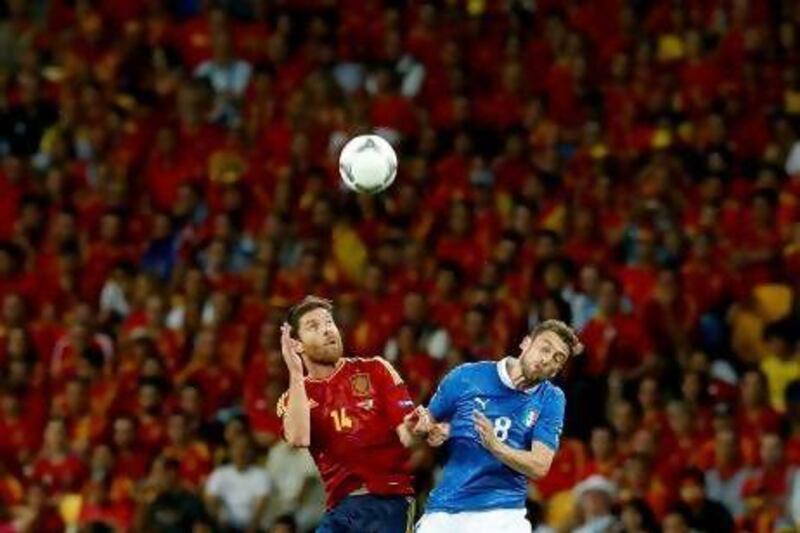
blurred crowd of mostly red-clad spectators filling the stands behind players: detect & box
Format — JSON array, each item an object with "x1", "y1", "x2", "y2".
[{"x1": 0, "y1": 0, "x2": 800, "y2": 533}]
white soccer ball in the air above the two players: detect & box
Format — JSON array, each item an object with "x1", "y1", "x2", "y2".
[{"x1": 339, "y1": 135, "x2": 397, "y2": 194}]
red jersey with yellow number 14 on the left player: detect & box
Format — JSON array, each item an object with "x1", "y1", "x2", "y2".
[{"x1": 278, "y1": 357, "x2": 414, "y2": 508}]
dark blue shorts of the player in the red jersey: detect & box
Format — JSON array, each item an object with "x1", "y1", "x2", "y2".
[{"x1": 317, "y1": 494, "x2": 415, "y2": 533}]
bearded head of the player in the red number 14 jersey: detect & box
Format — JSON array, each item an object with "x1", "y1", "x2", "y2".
[{"x1": 287, "y1": 296, "x2": 342, "y2": 364}]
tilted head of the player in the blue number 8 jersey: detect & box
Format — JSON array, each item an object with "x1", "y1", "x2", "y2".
[{"x1": 519, "y1": 320, "x2": 583, "y2": 382}]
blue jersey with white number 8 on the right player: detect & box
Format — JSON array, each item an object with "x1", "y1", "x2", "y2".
[{"x1": 426, "y1": 359, "x2": 565, "y2": 513}]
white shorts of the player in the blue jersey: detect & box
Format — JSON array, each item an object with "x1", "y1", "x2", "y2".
[{"x1": 414, "y1": 509, "x2": 531, "y2": 533}]
